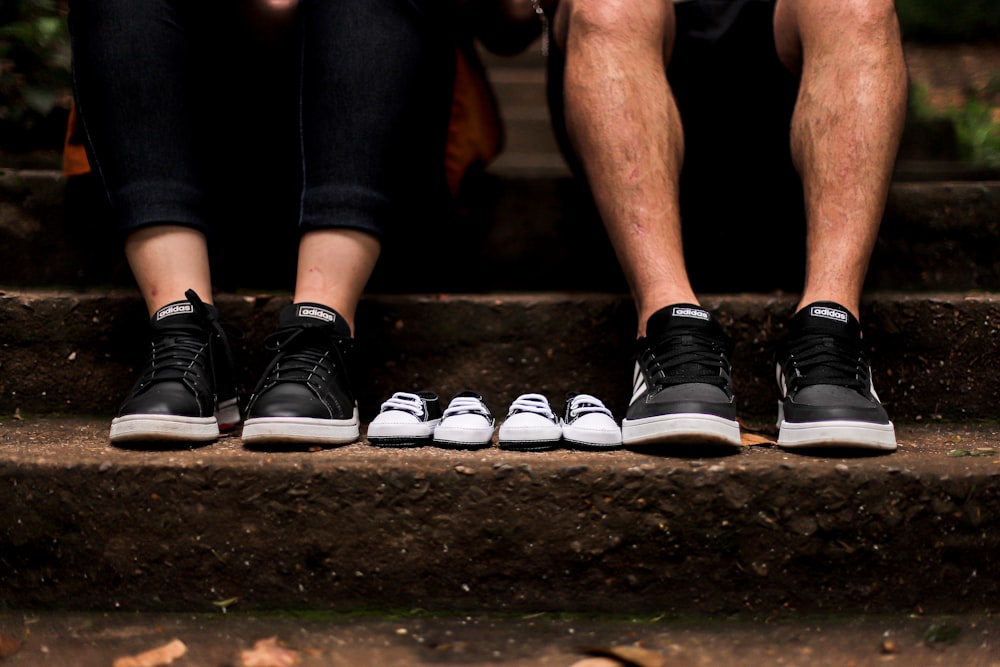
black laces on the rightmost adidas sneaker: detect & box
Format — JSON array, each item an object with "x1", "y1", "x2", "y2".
[{"x1": 784, "y1": 334, "x2": 871, "y2": 394}]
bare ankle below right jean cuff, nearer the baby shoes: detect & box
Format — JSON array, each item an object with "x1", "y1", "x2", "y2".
[{"x1": 294, "y1": 229, "x2": 381, "y2": 331}]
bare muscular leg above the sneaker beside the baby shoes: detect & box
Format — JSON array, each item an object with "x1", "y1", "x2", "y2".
[{"x1": 555, "y1": 0, "x2": 698, "y2": 336}]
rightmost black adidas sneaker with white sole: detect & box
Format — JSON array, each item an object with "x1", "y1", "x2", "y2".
[{"x1": 776, "y1": 301, "x2": 896, "y2": 451}]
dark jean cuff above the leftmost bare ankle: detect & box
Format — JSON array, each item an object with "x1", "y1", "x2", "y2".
[{"x1": 111, "y1": 181, "x2": 212, "y2": 236}]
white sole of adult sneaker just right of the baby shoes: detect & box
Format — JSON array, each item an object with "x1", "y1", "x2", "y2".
[{"x1": 622, "y1": 413, "x2": 742, "y2": 447}]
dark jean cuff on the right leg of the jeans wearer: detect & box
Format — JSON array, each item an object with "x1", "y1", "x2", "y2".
[{"x1": 299, "y1": 186, "x2": 393, "y2": 240}]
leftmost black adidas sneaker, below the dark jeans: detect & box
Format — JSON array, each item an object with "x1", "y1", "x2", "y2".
[{"x1": 110, "y1": 290, "x2": 240, "y2": 443}]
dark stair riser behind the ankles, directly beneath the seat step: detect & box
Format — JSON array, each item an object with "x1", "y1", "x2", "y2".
[{"x1": 0, "y1": 169, "x2": 1000, "y2": 293}]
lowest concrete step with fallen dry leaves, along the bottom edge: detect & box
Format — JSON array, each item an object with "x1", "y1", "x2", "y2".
[{"x1": 0, "y1": 604, "x2": 1000, "y2": 667}]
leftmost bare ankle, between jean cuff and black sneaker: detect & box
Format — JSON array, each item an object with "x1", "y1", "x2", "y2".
[{"x1": 125, "y1": 225, "x2": 212, "y2": 315}]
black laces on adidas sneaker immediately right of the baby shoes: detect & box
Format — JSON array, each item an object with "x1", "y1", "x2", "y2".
[{"x1": 639, "y1": 333, "x2": 730, "y2": 393}]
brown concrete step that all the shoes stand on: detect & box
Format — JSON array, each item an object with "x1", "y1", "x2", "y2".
[{"x1": 0, "y1": 417, "x2": 1000, "y2": 618}]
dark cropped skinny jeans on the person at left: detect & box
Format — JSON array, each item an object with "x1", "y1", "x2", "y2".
[{"x1": 69, "y1": 0, "x2": 454, "y2": 238}]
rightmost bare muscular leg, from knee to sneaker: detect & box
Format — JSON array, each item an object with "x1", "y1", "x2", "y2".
[{"x1": 775, "y1": 0, "x2": 907, "y2": 317}]
